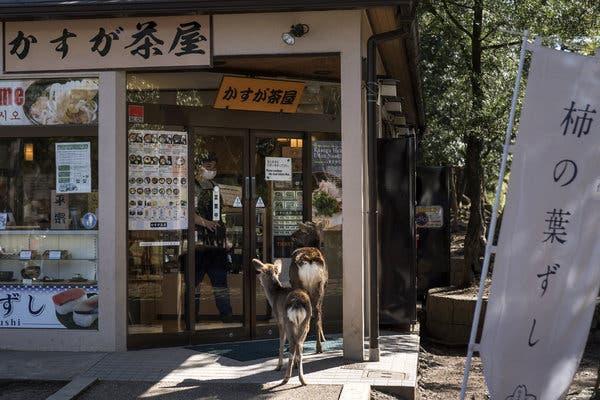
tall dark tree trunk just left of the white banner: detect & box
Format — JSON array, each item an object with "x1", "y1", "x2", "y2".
[{"x1": 461, "y1": 0, "x2": 485, "y2": 286}]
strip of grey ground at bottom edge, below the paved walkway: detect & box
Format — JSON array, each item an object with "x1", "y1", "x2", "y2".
[{"x1": 77, "y1": 380, "x2": 342, "y2": 400}]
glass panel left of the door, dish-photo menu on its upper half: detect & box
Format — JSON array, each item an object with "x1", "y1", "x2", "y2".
[{"x1": 127, "y1": 125, "x2": 188, "y2": 334}]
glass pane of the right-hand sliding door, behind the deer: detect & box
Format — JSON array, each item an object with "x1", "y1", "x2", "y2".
[{"x1": 252, "y1": 133, "x2": 304, "y2": 330}]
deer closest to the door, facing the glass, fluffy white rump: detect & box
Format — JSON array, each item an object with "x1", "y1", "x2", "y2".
[{"x1": 290, "y1": 222, "x2": 329, "y2": 353}]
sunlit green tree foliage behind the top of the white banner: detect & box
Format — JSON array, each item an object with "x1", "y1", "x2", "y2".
[{"x1": 419, "y1": 0, "x2": 600, "y2": 196}]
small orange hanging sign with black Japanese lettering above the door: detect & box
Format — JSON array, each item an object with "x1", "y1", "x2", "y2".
[{"x1": 214, "y1": 76, "x2": 304, "y2": 113}]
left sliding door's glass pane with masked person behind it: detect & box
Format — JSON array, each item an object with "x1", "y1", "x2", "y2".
[{"x1": 190, "y1": 128, "x2": 248, "y2": 330}]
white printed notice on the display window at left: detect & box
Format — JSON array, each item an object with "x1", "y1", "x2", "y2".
[{"x1": 56, "y1": 142, "x2": 92, "y2": 193}]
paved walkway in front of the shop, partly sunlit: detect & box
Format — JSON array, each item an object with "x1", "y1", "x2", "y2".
[{"x1": 0, "y1": 335, "x2": 419, "y2": 400}]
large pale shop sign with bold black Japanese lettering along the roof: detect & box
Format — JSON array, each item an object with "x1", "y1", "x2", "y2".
[{"x1": 3, "y1": 15, "x2": 212, "y2": 72}]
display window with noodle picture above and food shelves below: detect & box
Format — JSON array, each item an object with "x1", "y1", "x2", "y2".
[{"x1": 0, "y1": 78, "x2": 101, "y2": 329}]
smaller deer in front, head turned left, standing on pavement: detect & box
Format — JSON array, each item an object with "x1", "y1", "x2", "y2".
[{"x1": 252, "y1": 259, "x2": 312, "y2": 385}]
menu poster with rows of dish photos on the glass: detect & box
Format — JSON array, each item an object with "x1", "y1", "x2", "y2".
[{"x1": 128, "y1": 130, "x2": 188, "y2": 230}]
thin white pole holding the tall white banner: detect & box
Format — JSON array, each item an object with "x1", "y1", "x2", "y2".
[{"x1": 460, "y1": 30, "x2": 529, "y2": 400}]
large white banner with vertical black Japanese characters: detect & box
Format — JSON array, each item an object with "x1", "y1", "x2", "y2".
[{"x1": 480, "y1": 48, "x2": 600, "y2": 400}]
